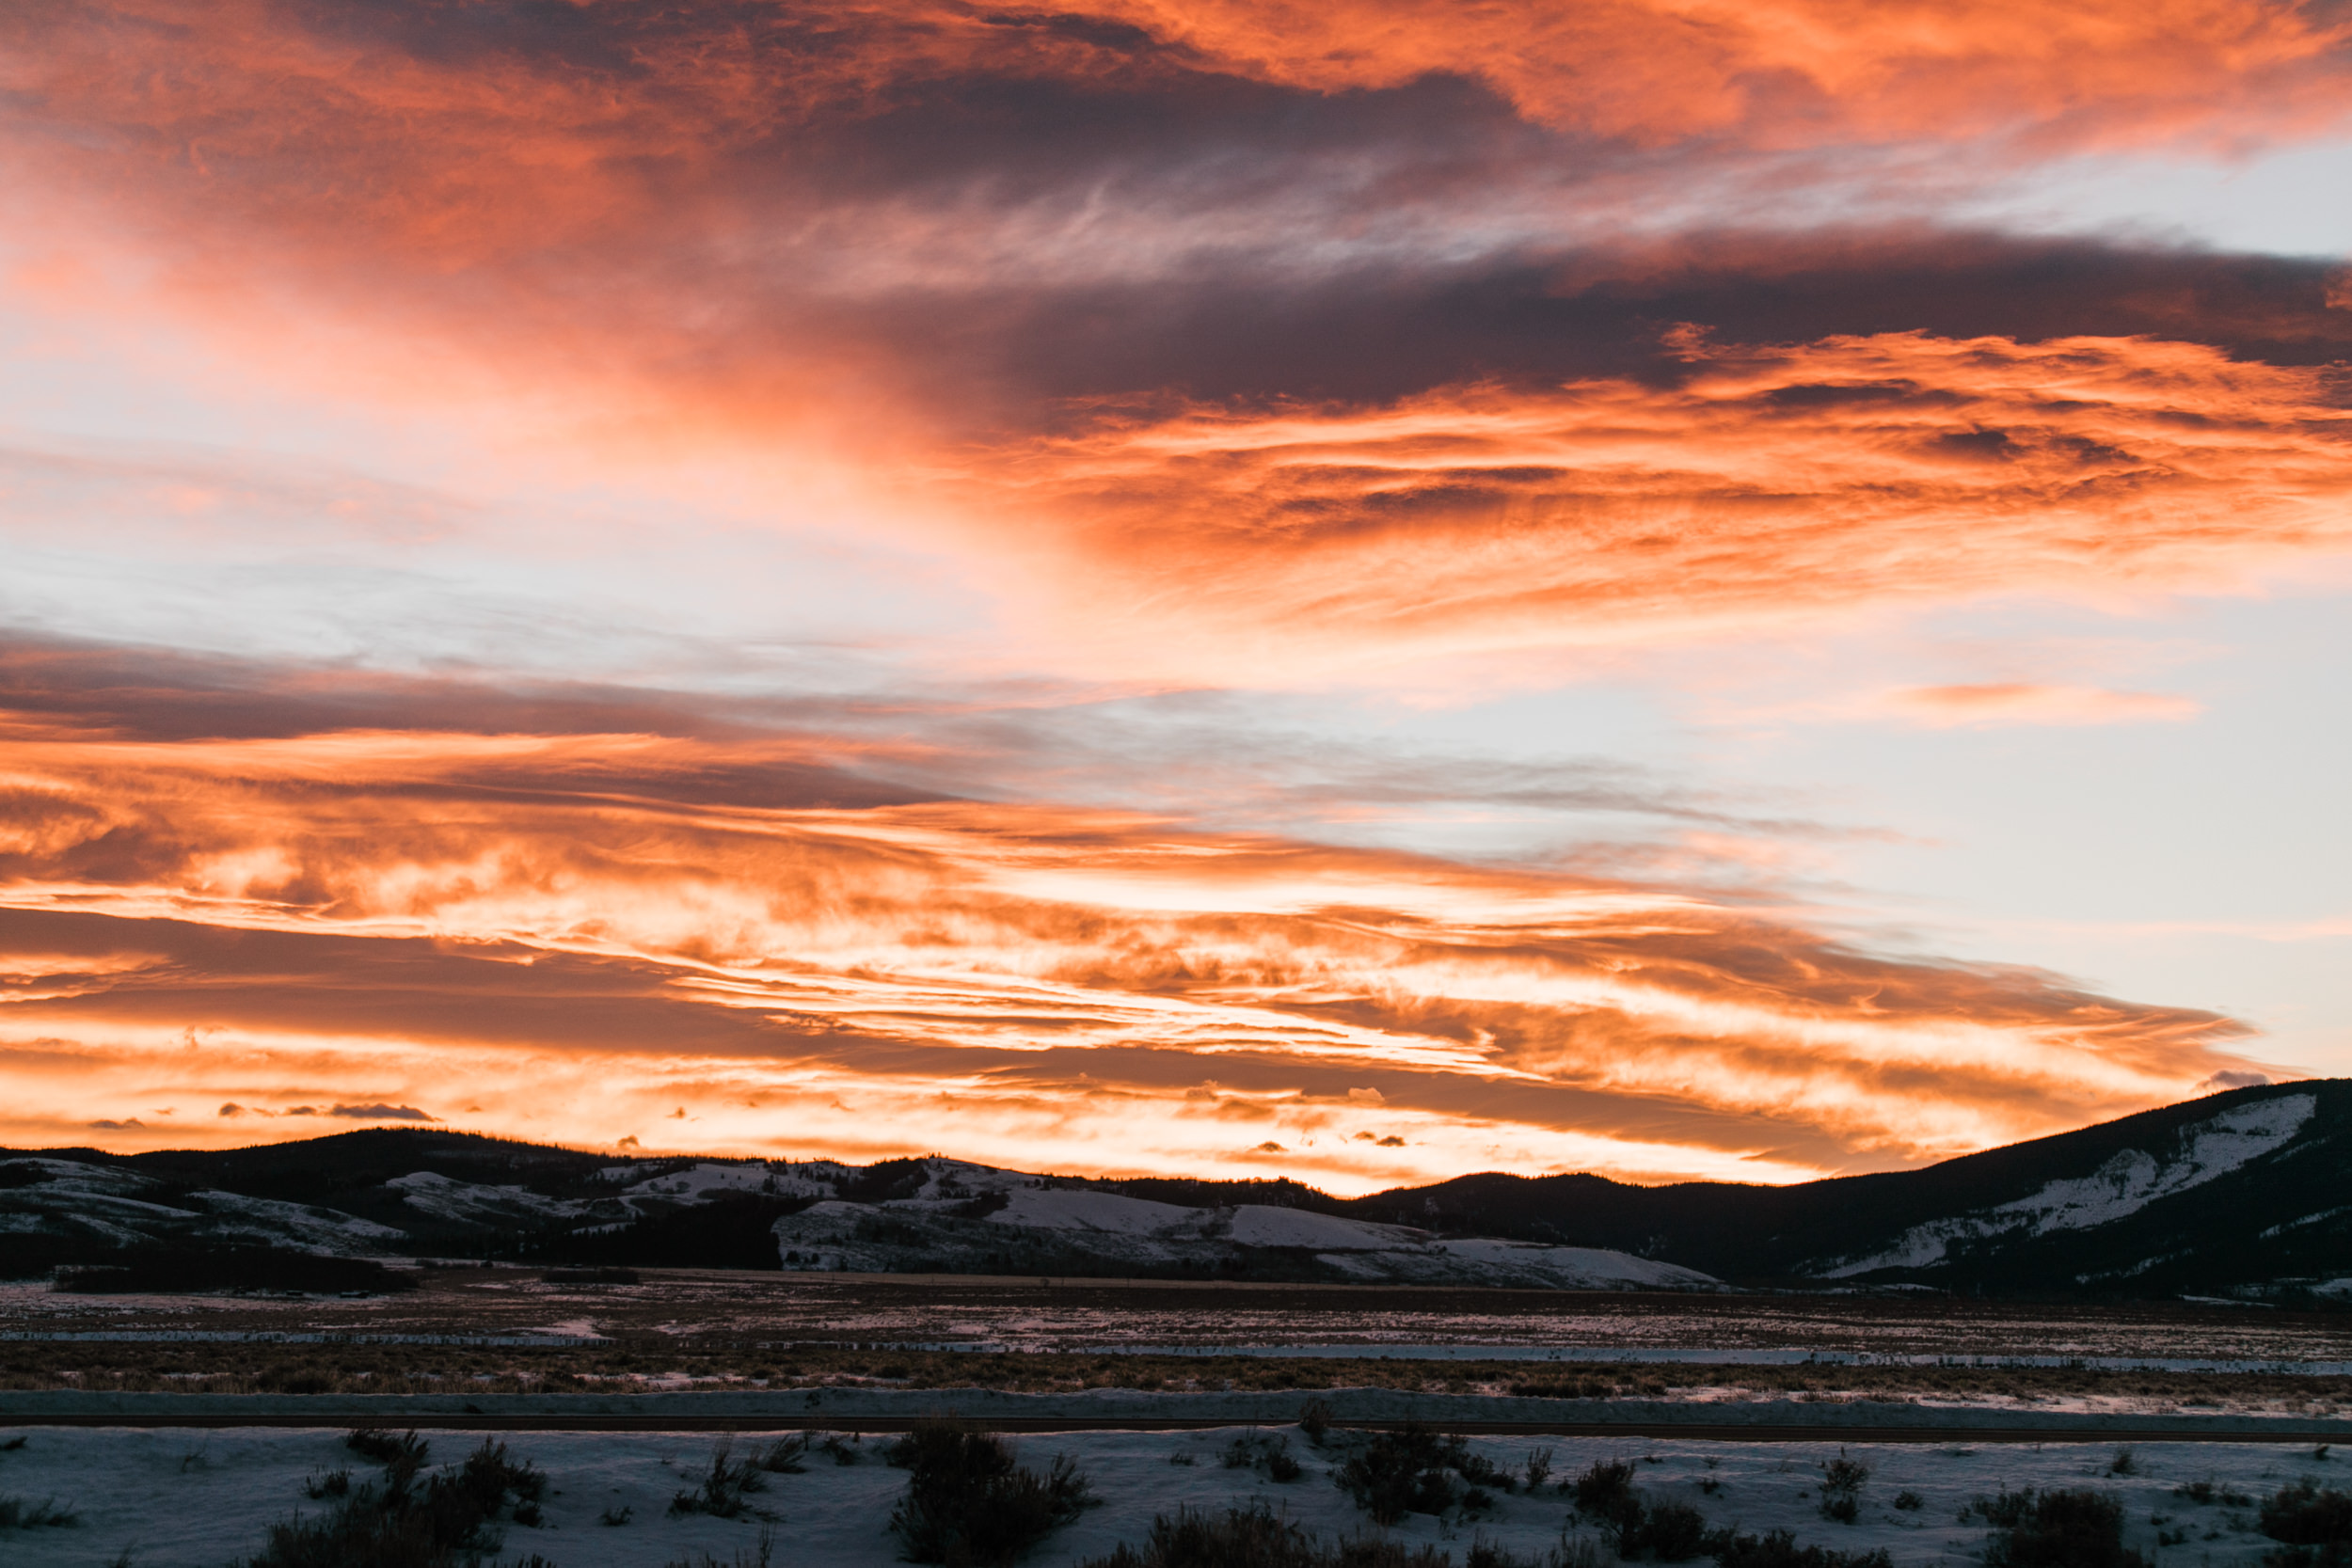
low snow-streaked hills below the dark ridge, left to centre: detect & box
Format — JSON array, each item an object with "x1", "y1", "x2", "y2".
[{"x1": 0, "y1": 1157, "x2": 1717, "y2": 1291}]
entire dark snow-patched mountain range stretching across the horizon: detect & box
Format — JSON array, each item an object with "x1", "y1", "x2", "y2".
[{"x1": 0, "y1": 1079, "x2": 2352, "y2": 1303}]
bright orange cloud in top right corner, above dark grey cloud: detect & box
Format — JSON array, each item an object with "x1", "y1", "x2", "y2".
[{"x1": 1091, "y1": 0, "x2": 2352, "y2": 143}]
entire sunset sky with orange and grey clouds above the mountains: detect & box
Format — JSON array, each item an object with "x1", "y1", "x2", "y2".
[{"x1": 0, "y1": 0, "x2": 2352, "y2": 1192}]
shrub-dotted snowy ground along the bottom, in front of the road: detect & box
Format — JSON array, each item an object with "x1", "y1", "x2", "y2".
[{"x1": 0, "y1": 1427, "x2": 2352, "y2": 1568}]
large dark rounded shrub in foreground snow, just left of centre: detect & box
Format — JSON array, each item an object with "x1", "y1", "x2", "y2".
[{"x1": 887, "y1": 1420, "x2": 1094, "y2": 1568}]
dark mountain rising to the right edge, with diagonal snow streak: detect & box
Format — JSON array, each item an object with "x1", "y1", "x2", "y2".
[{"x1": 1343, "y1": 1079, "x2": 2352, "y2": 1295}]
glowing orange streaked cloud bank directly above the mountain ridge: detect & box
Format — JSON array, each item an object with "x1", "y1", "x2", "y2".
[{"x1": 0, "y1": 705, "x2": 2277, "y2": 1187}]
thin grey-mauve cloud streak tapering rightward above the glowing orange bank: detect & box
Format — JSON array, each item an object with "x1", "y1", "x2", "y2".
[{"x1": 0, "y1": 637, "x2": 1853, "y2": 850}]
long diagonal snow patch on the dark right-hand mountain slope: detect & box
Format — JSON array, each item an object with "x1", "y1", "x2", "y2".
[{"x1": 1816, "y1": 1096, "x2": 2319, "y2": 1279}]
